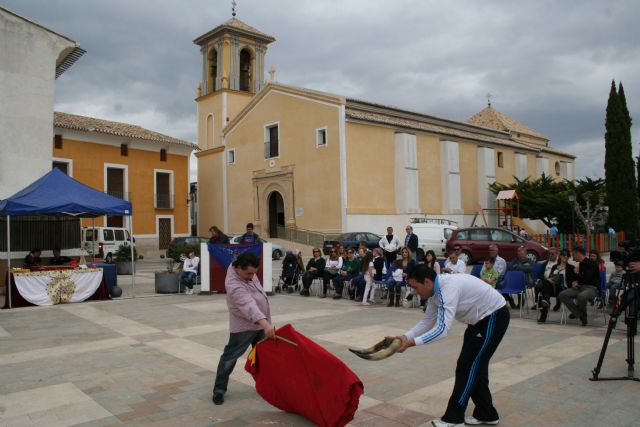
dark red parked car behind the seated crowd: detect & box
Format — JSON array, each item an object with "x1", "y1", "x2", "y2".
[{"x1": 447, "y1": 227, "x2": 547, "y2": 265}]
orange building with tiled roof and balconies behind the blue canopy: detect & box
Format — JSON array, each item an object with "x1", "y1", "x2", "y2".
[{"x1": 51, "y1": 112, "x2": 199, "y2": 256}]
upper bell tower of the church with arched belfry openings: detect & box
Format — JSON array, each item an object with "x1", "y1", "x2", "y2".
[{"x1": 193, "y1": 10, "x2": 275, "y2": 150}]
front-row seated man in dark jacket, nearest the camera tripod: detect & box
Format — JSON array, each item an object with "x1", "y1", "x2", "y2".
[{"x1": 558, "y1": 246, "x2": 600, "y2": 326}]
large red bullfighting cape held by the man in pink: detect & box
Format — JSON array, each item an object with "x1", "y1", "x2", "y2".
[{"x1": 245, "y1": 324, "x2": 364, "y2": 427}]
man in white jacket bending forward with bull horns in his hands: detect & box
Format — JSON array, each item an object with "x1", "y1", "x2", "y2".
[{"x1": 397, "y1": 265, "x2": 509, "y2": 427}]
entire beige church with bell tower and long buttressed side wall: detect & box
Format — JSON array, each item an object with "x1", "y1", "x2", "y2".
[{"x1": 195, "y1": 18, "x2": 575, "y2": 236}]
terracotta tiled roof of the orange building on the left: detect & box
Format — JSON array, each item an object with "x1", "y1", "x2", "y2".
[{"x1": 53, "y1": 111, "x2": 200, "y2": 150}]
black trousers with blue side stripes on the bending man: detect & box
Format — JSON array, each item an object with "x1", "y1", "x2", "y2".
[{"x1": 442, "y1": 305, "x2": 510, "y2": 424}]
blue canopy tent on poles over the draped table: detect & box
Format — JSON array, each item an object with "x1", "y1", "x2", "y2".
[{"x1": 0, "y1": 168, "x2": 135, "y2": 308}]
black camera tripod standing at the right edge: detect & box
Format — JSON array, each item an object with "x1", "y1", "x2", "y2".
[{"x1": 589, "y1": 273, "x2": 640, "y2": 381}]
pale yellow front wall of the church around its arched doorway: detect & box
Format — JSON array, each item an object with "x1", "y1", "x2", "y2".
[{"x1": 222, "y1": 91, "x2": 341, "y2": 233}]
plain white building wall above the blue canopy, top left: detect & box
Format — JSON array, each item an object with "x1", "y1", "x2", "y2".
[{"x1": 0, "y1": 8, "x2": 75, "y2": 199}]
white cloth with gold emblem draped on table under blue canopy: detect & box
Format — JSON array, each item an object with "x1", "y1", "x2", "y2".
[{"x1": 13, "y1": 268, "x2": 102, "y2": 305}]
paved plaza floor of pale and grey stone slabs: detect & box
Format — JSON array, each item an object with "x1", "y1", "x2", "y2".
[{"x1": 0, "y1": 262, "x2": 640, "y2": 427}]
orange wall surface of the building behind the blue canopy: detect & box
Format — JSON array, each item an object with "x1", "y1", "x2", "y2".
[{"x1": 53, "y1": 139, "x2": 190, "y2": 234}]
